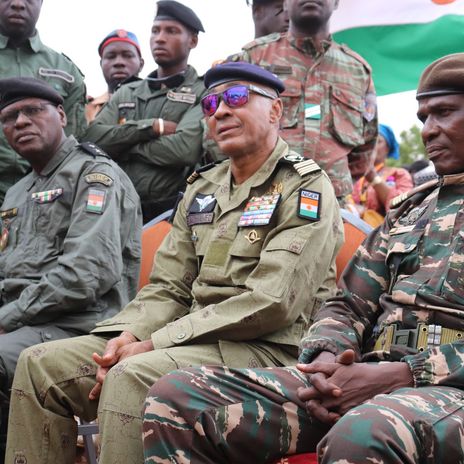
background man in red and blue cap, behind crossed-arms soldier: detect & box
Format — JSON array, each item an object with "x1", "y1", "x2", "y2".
[{"x1": 85, "y1": 29, "x2": 144, "y2": 122}]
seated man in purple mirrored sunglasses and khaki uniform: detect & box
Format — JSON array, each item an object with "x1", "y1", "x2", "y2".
[{"x1": 7, "y1": 63, "x2": 342, "y2": 464}]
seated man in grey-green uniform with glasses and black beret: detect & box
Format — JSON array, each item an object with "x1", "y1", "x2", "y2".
[{"x1": 0, "y1": 78, "x2": 142, "y2": 462}]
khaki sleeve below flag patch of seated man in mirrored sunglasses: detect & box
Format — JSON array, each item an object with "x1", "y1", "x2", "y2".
[{"x1": 152, "y1": 174, "x2": 342, "y2": 349}]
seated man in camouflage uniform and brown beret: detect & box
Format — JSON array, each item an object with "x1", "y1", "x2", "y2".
[{"x1": 140, "y1": 53, "x2": 464, "y2": 464}]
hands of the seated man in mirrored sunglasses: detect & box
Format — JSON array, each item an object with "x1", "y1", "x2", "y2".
[{"x1": 89, "y1": 332, "x2": 153, "y2": 400}]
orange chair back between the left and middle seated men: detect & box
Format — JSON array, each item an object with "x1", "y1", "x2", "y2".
[{"x1": 139, "y1": 210, "x2": 172, "y2": 290}]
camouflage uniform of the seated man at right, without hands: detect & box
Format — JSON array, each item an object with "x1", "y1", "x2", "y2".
[{"x1": 144, "y1": 174, "x2": 464, "y2": 464}]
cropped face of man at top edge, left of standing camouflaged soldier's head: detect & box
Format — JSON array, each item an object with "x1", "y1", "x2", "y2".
[{"x1": 247, "y1": 0, "x2": 288, "y2": 38}]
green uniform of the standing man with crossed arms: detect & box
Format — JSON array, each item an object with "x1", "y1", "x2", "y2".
[{"x1": 85, "y1": 66, "x2": 205, "y2": 220}]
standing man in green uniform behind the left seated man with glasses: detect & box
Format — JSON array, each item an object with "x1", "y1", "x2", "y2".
[{"x1": 0, "y1": 0, "x2": 87, "y2": 205}]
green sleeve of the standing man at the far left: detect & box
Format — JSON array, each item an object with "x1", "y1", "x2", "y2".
[{"x1": 63, "y1": 62, "x2": 87, "y2": 140}]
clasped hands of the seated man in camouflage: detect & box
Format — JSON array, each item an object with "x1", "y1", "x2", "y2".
[{"x1": 297, "y1": 350, "x2": 414, "y2": 425}]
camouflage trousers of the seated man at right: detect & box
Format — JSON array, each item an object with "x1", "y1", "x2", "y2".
[{"x1": 143, "y1": 367, "x2": 464, "y2": 464}]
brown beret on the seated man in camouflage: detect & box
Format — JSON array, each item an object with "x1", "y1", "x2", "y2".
[{"x1": 416, "y1": 53, "x2": 464, "y2": 100}]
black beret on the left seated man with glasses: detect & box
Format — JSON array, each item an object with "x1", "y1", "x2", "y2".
[{"x1": 0, "y1": 77, "x2": 63, "y2": 111}]
